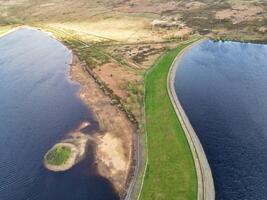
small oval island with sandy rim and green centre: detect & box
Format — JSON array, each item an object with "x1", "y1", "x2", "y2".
[{"x1": 44, "y1": 142, "x2": 78, "y2": 171}]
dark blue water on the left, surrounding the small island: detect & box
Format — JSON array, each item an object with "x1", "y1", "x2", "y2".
[{"x1": 0, "y1": 29, "x2": 118, "y2": 200}]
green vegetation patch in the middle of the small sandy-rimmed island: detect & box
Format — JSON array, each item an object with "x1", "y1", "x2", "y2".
[{"x1": 46, "y1": 145, "x2": 71, "y2": 165}]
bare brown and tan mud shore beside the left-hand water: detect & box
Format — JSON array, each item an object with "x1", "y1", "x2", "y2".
[{"x1": 70, "y1": 52, "x2": 137, "y2": 198}]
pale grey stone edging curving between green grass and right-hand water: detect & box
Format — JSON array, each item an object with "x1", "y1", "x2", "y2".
[{"x1": 167, "y1": 39, "x2": 215, "y2": 200}]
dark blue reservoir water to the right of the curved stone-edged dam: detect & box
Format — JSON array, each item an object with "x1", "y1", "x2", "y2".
[{"x1": 175, "y1": 41, "x2": 267, "y2": 200}]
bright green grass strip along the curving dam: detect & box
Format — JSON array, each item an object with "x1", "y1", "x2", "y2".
[{"x1": 141, "y1": 42, "x2": 197, "y2": 200}]
